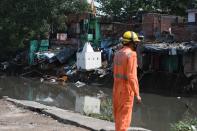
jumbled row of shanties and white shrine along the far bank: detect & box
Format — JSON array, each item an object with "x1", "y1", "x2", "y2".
[{"x1": 1, "y1": 4, "x2": 197, "y2": 90}]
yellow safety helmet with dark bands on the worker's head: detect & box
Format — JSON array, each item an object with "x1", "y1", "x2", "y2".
[{"x1": 122, "y1": 31, "x2": 140, "y2": 44}]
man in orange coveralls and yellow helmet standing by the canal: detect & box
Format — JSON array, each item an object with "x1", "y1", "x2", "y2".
[{"x1": 113, "y1": 31, "x2": 141, "y2": 131}]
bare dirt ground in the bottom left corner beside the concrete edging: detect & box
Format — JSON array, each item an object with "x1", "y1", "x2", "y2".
[{"x1": 0, "y1": 99, "x2": 88, "y2": 131}]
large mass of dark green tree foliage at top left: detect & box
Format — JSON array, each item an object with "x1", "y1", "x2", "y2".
[{"x1": 0, "y1": 0, "x2": 87, "y2": 56}]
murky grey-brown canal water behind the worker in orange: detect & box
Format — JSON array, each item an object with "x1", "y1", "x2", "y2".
[{"x1": 0, "y1": 77, "x2": 197, "y2": 131}]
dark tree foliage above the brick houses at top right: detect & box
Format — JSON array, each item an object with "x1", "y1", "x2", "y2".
[{"x1": 97, "y1": 0, "x2": 197, "y2": 18}]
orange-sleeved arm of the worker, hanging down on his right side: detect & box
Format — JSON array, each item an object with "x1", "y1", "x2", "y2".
[{"x1": 127, "y1": 53, "x2": 140, "y2": 97}]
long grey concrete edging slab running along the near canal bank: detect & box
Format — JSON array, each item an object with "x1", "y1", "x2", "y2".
[{"x1": 5, "y1": 97, "x2": 150, "y2": 131}]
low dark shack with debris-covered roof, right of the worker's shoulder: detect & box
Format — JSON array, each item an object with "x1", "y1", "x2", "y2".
[{"x1": 139, "y1": 42, "x2": 197, "y2": 76}]
